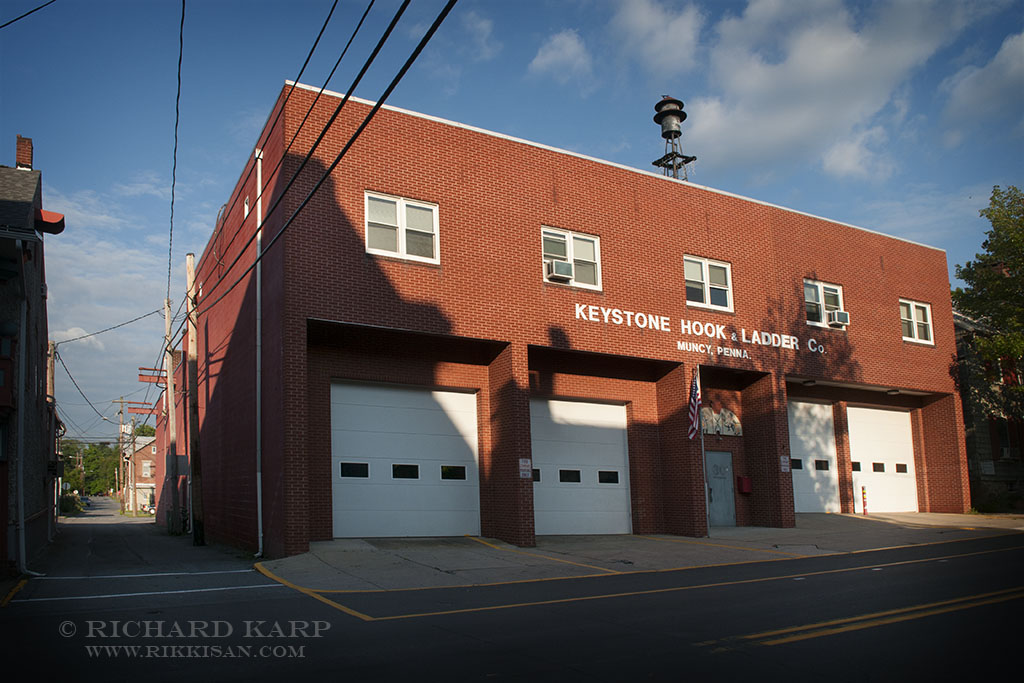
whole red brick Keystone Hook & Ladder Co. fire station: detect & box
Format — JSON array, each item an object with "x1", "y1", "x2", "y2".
[{"x1": 180, "y1": 86, "x2": 970, "y2": 555}]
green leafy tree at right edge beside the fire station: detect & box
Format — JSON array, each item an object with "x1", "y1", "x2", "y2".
[{"x1": 952, "y1": 185, "x2": 1024, "y2": 420}]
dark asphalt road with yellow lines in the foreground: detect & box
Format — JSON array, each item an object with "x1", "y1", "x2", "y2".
[{"x1": 0, "y1": 499, "x2": 1024, "y2": 683}]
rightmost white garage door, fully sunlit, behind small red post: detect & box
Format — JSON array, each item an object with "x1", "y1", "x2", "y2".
[{"x1": 846, "y1": 408, "x2": 918, "y2": 514}]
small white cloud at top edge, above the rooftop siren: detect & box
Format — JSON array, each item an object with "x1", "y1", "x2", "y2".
[{"x1": 611, "y1": 0, "x2": 705, "y2": 76}]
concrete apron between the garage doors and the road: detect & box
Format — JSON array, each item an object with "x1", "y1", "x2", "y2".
[{"x1": 261, "y1": 513, "x2": 1024, "y2": 591}]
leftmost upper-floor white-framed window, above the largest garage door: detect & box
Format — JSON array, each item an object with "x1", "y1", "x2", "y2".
[{"x1": 366, "y1": 193, "x2": 440, "y2": 263}]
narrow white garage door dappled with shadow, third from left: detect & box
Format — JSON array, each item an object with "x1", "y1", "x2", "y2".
[{"x1": 788, "y1": 400, "x2": 840, "y2": 512}]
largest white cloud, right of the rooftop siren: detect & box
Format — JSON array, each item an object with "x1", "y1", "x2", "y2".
[{"x1": 684, "y1": 0, "x2": 967, "y2": 175}]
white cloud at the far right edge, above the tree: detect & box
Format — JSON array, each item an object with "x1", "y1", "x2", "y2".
[{"x1": 940, "y1": 33, "x2": 1024, "y2": 143}]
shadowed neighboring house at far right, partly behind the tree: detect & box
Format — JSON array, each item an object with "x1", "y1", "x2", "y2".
[{"x1": 953, "y1": 311, "x2": 1024, "y2": 512}]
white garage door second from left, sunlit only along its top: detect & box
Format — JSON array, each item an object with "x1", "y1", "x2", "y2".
[{"x1": 529, "y1": 399, "x2": 632, "y2": 535}]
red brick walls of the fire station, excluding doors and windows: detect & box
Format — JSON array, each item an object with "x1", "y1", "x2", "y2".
[{"x1": 184, "y1": 83, "x2": 967, "y2": 555}]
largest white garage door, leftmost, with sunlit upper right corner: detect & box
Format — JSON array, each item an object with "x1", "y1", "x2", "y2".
[{"x1": 331, "y1": 384, "x2": 480, "y2": 538}]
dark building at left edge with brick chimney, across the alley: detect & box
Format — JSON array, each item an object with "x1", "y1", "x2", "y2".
[{"x1": 0, "y1": 135, "x2": 65, "y2": 571}]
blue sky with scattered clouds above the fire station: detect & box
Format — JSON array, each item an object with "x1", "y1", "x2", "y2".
[{"x1": 0, "y1": 0, "x2": 1024, "y2": 438}]
